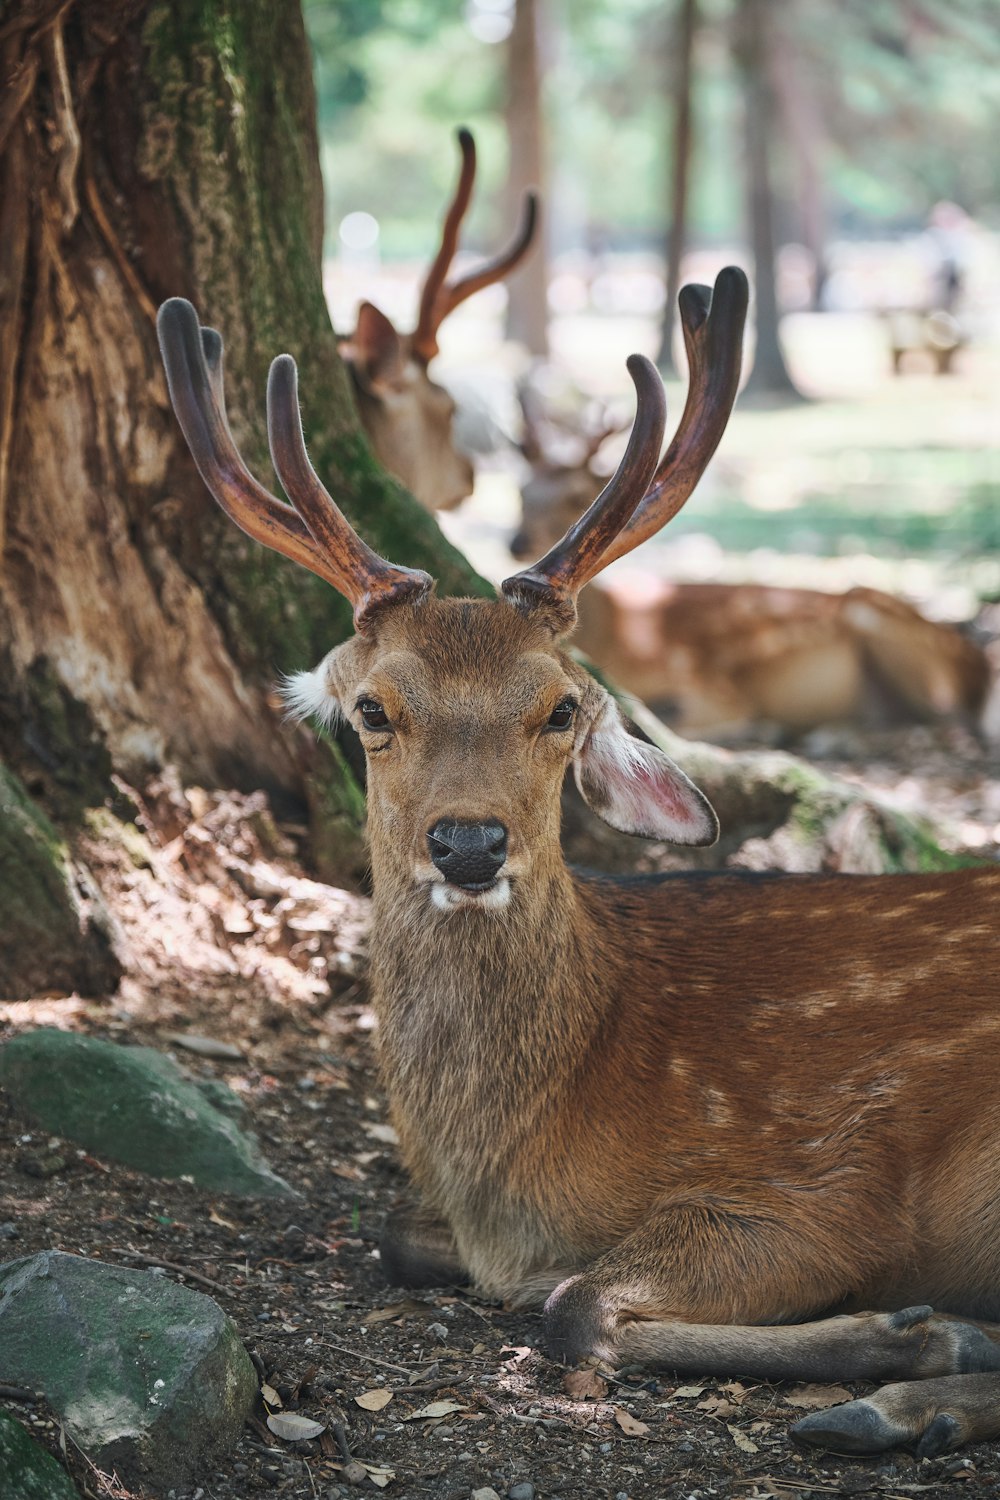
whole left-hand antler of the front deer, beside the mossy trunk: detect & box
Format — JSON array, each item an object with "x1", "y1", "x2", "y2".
[{"x1": 157, "y1": 297, "x2": 433, "y2": 630}]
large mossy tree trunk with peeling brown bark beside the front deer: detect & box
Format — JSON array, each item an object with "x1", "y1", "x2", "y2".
[{"x1": 0, "y1": 0, "x2": 483, "y2": 869}]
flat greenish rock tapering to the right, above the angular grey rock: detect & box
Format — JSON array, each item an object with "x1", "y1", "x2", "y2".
[{"x1": 0, "y1": 1028, "x2": 294, "y2": 1197}]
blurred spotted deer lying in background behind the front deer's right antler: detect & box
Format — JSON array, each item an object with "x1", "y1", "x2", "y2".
[{"x1": 511, "y1": 396, "x2": 990, "y2": 735}]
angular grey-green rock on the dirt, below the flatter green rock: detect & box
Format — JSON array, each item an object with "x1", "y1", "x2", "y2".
[{"x1": 0, "y1": 1250, "x2": 256, "y2": 1500}]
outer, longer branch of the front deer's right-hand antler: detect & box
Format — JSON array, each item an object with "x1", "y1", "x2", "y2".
[{"x1": 594, "y1": 266, "x2": 750, "y2": 573}]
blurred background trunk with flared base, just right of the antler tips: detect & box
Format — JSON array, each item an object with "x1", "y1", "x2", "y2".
[{"x1": 736, "y1": 0, "x2": 799, "y2": 399}]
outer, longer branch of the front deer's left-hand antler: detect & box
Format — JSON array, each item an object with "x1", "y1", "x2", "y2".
[{"x1": 156, "y1": 297, "x2": 339, "y2": 588}]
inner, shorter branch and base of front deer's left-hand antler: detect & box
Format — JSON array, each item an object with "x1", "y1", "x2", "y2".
[{"x1": 267, "y1": 354, "x2": 433, "y2": 630}]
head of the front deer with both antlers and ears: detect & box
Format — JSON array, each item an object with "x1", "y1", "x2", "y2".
[{"x1": 159, "y1": 269, "x2": 747, "y2": 912}]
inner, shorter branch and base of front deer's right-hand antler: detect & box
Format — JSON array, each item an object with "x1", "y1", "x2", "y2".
[{"x1": 502, "y1": 354, "x2": 667, "y2": 629}]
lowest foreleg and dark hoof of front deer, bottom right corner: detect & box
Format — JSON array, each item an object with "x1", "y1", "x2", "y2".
[{"x1": 792, "y1": 1374, "x2": 1000, "y2": 1458}]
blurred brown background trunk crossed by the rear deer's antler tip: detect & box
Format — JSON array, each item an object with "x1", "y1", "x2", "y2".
[{"x1": 505, "y1": 0, "x2": 549, "y2": 359}]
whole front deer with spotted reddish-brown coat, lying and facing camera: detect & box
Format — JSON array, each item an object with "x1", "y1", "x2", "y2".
[{"x1": 160, "y1": 270, "x2": 1000, "y2": 1454}]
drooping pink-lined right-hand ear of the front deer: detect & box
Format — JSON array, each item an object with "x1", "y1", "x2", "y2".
[{"x1": 573, "y1": 701, "x2": 718, "y2": 846}]
